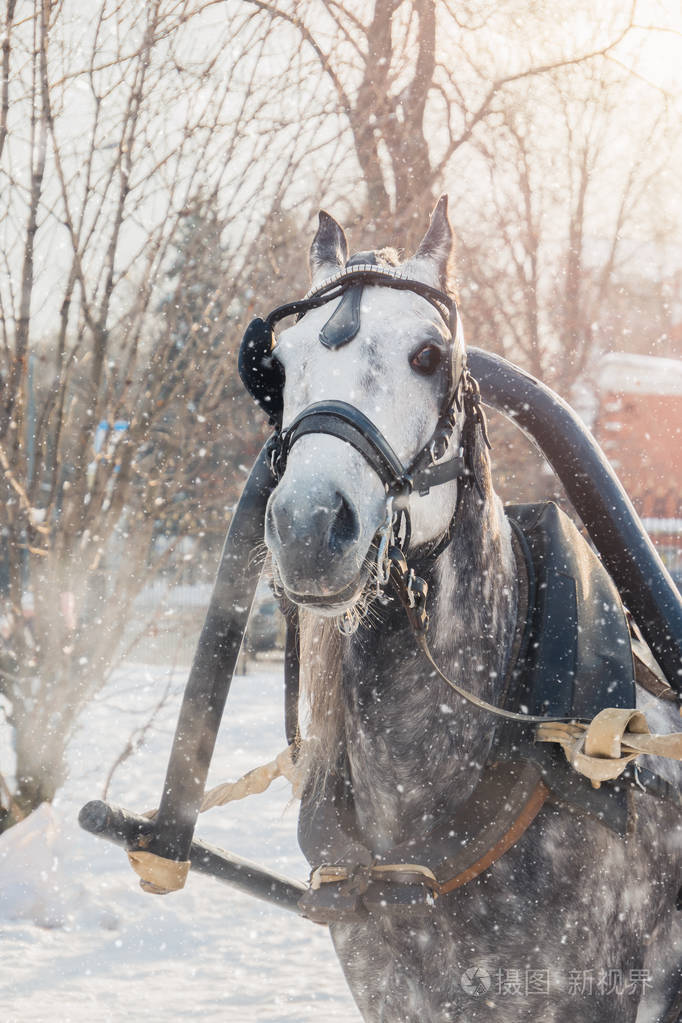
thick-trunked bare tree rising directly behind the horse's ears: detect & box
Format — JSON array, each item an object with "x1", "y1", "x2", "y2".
[{"x1": 247, "y1": 0, "x2": 636, "y2": 246}]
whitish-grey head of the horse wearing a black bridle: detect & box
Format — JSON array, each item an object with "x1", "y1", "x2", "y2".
[{"x1": 265, "y1": 196, "x2": 472, "y2": 616}]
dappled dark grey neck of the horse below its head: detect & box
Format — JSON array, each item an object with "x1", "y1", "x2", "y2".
[{"x1": 342, "y1": 482, "x2": 516, "y2": 851}]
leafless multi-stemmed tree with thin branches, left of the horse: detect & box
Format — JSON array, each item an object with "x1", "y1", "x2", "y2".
[{"x1": 0, "y1": 0, "x2": 315, "y2": 827}]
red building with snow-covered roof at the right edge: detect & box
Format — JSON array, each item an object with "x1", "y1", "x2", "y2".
[{"x1": 593, "y1": 353, "x2": 682, "y2": 580}]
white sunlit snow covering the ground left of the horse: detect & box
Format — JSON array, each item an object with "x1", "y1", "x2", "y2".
[{"x1": 0, "y1": 663, "x2": 360, "y2": 1023}]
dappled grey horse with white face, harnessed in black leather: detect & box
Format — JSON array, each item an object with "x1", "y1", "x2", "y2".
[{"x1": 266, "y1": 199, "x2": 682, "y2": 1023}]
